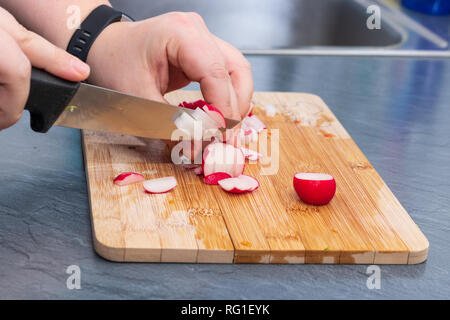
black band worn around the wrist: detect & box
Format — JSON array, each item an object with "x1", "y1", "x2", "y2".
[{"x1": 66, "y1": 5, "x2": 134, "y2": 62}]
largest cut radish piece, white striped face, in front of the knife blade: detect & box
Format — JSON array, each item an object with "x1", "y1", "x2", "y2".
[{"x1": 202, "y1": 142, "x2": 245, "y2": 177}]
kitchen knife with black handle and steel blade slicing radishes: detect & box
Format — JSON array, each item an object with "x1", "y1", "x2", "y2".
[{"x1": 25, "y1": 68, "x2": 243, "y2": 140}]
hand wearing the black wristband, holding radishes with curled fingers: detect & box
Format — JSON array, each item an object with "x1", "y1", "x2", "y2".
[{"x1": 88, "y1": 12, "x2": 253, "y2": 119}]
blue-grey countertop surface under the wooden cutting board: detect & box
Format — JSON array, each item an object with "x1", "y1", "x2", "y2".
[{"x1": 0, "y1": 6, "x2": 450, "y2": 299}]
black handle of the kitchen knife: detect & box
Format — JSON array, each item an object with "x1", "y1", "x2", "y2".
[{"x1": 25, "y1": 68, "x2": 80, "y2": 133}]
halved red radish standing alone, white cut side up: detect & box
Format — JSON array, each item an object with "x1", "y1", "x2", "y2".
[{"x1": 294, "y1": 172, "x2": 336, "y2": 206}]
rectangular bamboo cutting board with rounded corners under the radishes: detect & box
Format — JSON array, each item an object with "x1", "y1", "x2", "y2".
[{"x1": 82, "y1": 91, "x2": 428, "y2": 264}]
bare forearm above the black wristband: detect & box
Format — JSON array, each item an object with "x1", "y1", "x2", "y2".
[{"x1": 0, "y1": 0, "x2": 110, "y2": 49}]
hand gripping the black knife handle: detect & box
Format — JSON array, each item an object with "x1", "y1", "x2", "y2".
[{"x1": 0, "y1": 8, "x2": 89, "y2": 130}]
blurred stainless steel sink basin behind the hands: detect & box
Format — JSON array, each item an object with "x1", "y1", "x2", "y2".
[{"x1": 111, "y1": 0, "x2": 450, "y2": 55}]
